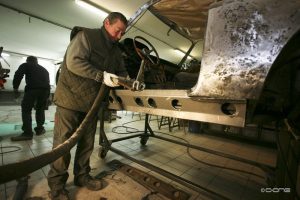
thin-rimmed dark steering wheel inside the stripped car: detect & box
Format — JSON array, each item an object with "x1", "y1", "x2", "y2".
[{"x1": 133, "y1": 36, "x2": 159, "y2": 65}]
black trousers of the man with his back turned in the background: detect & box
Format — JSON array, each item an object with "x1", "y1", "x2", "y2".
[{"x1": 21, "y1": 89, "x2": 50, "y2": 136}]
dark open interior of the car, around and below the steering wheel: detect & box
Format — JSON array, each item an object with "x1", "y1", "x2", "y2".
[{"x1": 120, "y1": 38, "x2": 201, "y2": 89}]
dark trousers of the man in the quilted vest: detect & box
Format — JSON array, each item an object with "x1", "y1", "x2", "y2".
[{"x1": 47, "y1": 106, "x2": 97, "y2": 191}]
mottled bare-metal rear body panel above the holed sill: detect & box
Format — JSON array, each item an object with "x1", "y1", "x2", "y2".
[{"x1": 189, "y1": 0, "x2": 300, "y2": 99}]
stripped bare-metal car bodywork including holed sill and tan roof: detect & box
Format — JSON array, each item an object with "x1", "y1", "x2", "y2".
[{"x1": 109, "y1": 0, "x2": 300, "y2": 127}]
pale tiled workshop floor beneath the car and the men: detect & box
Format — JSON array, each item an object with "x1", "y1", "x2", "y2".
[{"x1": 0, "y1": 106, "x2": 276, "y2": 200}]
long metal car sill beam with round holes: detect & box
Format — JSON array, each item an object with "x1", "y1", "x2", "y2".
[{"x1": 109, "y1": 90, "x2": 247, "y2": 127}]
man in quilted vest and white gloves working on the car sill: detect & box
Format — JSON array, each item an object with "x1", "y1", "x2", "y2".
[{"x1": 48, "y1": 12, "x2": 128, "y2": 199}]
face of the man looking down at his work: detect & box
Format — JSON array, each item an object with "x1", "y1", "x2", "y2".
[{"x1": 104, "y1": 19, "x2": 126, "y2": 42}]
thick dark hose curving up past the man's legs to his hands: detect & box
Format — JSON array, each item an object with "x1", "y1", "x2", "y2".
[{"x1": 0, "y1": 84, "x2": 109, "y2": 184}]
